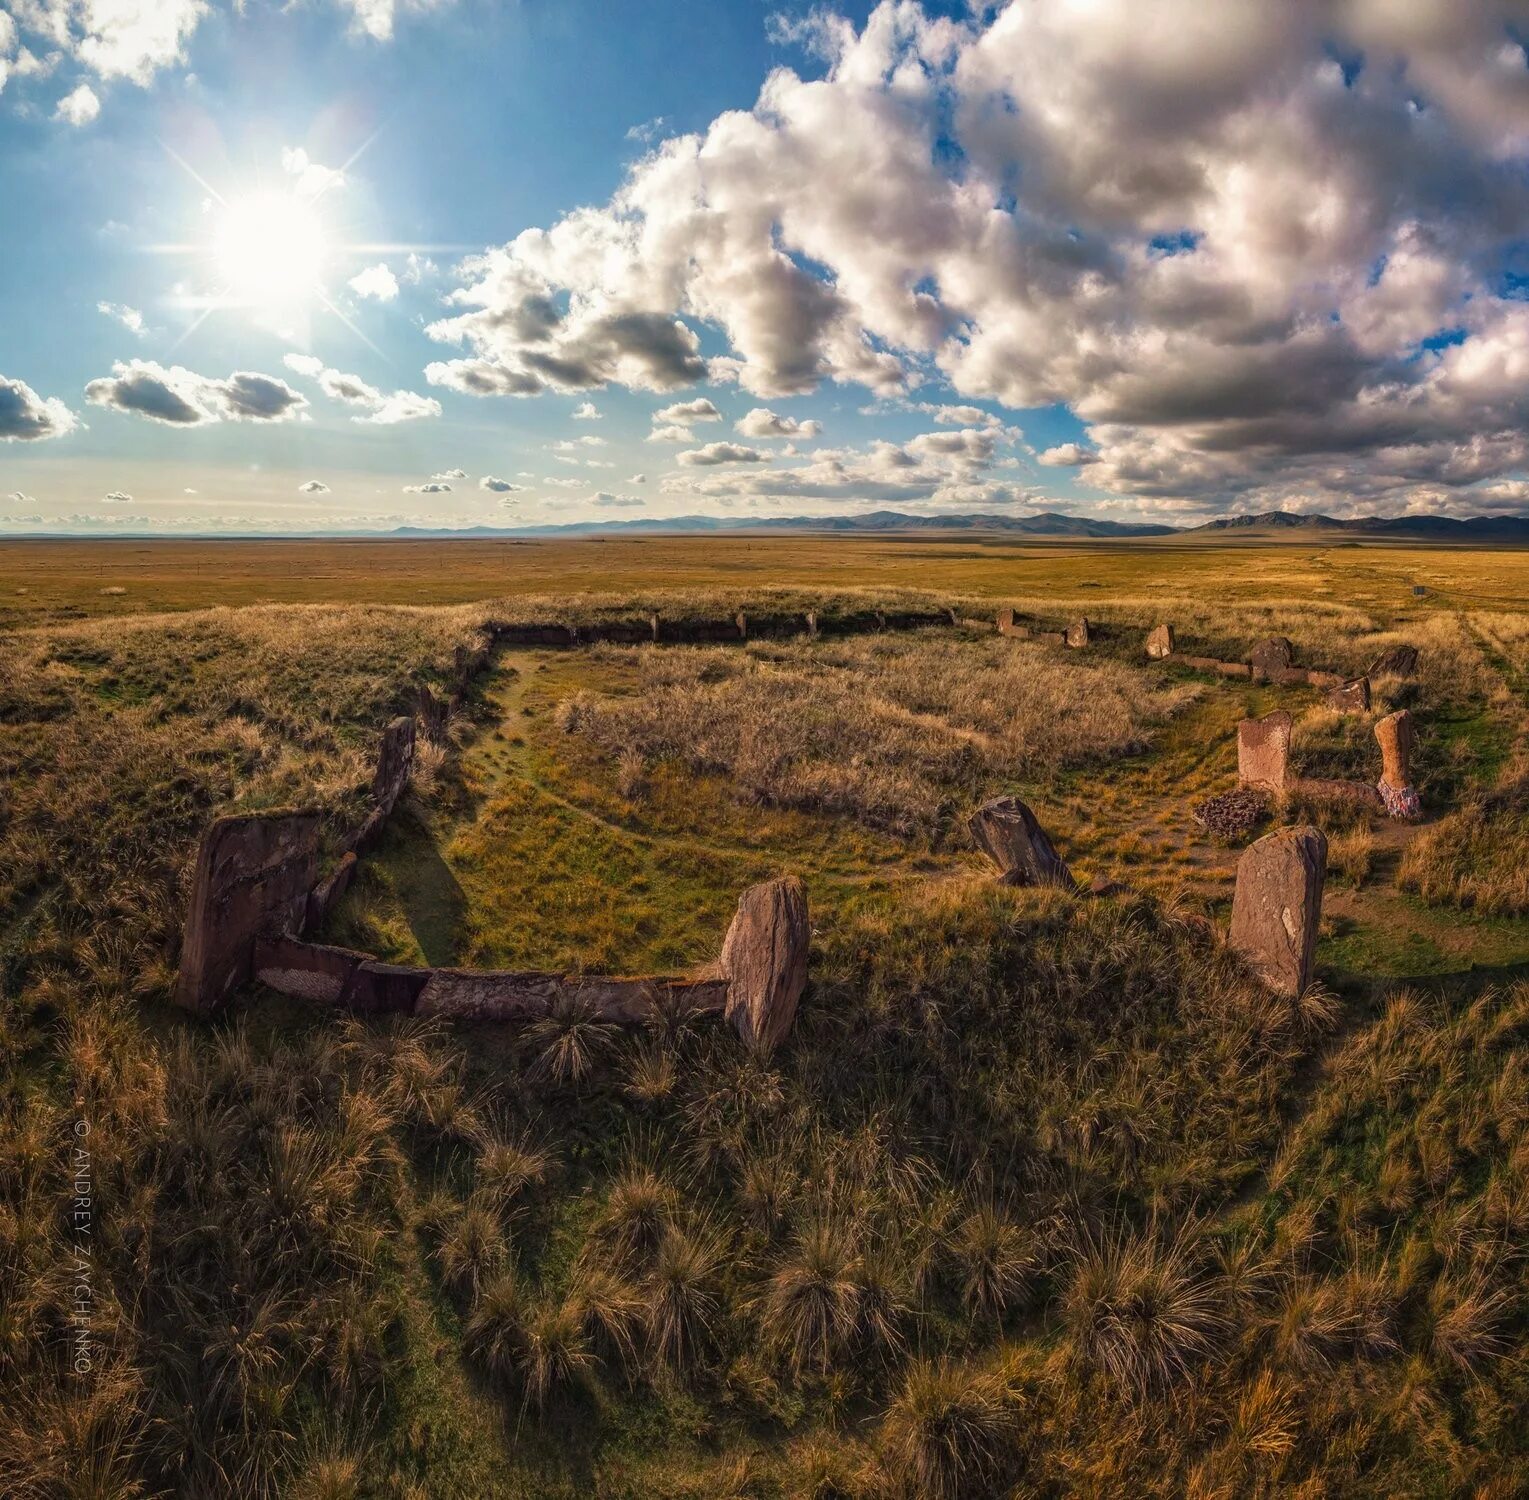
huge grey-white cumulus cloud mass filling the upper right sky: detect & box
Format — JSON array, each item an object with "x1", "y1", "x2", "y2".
[{"x1": 430, "y1": 0, "x2": 1529, "y2": 508}]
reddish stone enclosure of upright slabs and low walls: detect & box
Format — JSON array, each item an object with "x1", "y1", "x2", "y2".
[{"x1": 176, "y1": 596, "x2": 1417, "y2": 1052}]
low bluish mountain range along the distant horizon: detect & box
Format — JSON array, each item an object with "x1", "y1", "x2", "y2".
[{"x1": 379, "y1": 511, "x2": 1529, "y2": 544}]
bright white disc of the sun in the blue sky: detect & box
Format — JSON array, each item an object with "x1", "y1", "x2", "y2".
[{"x1": 213, "y1": 193, "x2": 329, "y2": 312}]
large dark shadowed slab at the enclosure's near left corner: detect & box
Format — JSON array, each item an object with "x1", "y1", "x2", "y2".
[{"x1": 176, "y1": 812, "x2": 318, "y2": 1011}]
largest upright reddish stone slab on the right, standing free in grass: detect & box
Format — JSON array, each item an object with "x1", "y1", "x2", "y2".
[{"x1": 1231, "y1": 827, "x2": 1327, "y2": 997}]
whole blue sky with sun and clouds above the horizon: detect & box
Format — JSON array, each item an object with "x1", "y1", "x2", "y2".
[{"x1": 0, "y1": 0, "x2": 1529, "y2": 535}]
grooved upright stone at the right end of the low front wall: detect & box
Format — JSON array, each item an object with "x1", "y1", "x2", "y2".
[{"x1": 719, "y1": 875, "x2": 812, "y2": 1052}]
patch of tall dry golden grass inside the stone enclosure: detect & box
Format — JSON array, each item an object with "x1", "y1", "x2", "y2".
[{"x1": 560, "y1": 633, "x2": 1197, "y2": 838}]
